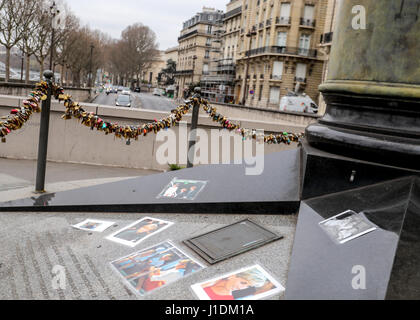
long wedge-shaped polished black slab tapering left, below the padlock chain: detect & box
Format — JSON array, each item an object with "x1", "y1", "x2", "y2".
[{"x1": 0, "y1": 149, "x2": 301, "y2": 214}]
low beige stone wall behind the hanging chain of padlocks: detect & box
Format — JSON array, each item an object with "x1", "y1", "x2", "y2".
[{"x1": 0, "y1": 96, "x2": 305, "y2": 170}]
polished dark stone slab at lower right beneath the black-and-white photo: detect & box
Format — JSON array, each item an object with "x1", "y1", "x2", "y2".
[{"x1": 286, "y1": 177, "x2": 420, "y2": 300}]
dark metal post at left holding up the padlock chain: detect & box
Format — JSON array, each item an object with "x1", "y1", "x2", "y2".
[{"x1": 35, "y1": 70, "x2": 54, "y2": 193}]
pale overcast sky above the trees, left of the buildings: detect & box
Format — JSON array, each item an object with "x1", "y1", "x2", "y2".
[{"x1": 67, "y1": 0, "x2": 229, "y2": 50}]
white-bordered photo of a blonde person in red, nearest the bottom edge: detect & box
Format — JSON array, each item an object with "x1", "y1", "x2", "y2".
[{"x1": 192, "y1": 265, "x2": 284, "y2": 300}]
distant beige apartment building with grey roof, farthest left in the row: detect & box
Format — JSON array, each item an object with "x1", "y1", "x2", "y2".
[{"x1": 176, "y1": 7, "x2": 223, "y2": 96}]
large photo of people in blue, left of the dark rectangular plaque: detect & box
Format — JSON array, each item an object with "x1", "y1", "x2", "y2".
[{"x1": 111, "y1": 241, "x2": 204, "y2": 296}]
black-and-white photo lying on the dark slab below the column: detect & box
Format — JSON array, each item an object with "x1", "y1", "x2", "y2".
[{"x1": 319, "y1": 210, "x2": 377, "y2": 244}]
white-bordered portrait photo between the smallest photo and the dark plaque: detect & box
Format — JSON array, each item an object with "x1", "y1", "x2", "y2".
[{"x1": 107, "y1": 218, "x2": 173, "y2": 247}]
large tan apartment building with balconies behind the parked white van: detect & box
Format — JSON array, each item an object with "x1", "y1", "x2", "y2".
[{"x1": 235, "y1": 0, "x2": 329, "y2": 108}]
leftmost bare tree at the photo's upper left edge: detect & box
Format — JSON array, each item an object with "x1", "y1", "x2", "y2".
[{"x1": 0, "y1": 0, "x2": 37, "y2": 82}]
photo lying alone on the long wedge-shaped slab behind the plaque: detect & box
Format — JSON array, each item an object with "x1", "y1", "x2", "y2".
[{"x1": 157, "y1": 178, "x2": 207, "y2": 201}]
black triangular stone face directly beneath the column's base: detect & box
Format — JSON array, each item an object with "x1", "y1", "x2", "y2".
[{"x1": 302, "y1": 141, "x2": 420, "y2": 200}]
